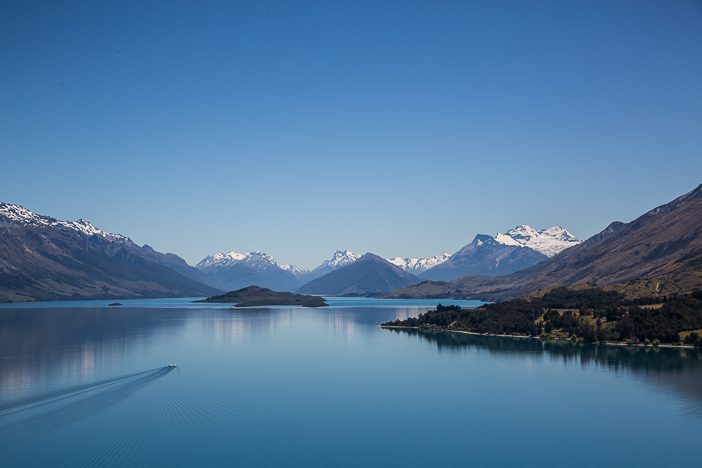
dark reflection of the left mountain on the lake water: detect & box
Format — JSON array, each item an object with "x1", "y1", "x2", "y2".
[{"x1": 0, "y1": 309, "x2": 187, "y2": 402}]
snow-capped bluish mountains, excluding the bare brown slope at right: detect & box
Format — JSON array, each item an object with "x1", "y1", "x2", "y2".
[{"x1": 0, "y1": 198, "x2": 579, "y2": 301}]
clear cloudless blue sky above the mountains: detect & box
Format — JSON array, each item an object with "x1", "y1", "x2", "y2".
[{"x1": 0, "y1": 0, "x2": 702, "y2": 267}]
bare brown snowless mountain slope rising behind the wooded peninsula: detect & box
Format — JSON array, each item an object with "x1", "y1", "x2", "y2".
[{"x1": 388, "y1": 185, "x2": 702, "y2": 300}]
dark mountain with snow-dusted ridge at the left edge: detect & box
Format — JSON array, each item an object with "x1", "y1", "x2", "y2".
[{"x1": 0, "y1": 203, "x2": 218, "y2": 302}]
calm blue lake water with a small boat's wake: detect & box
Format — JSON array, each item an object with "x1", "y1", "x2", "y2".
[{"x1": 0, "y1": 299, "x2": 702, "y2": 467}]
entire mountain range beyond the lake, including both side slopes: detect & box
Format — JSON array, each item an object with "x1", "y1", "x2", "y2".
[{"x1": 15, "y1": 186, "x2": 702, "y2": 301}]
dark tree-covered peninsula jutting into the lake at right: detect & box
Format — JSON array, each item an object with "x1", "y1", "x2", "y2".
[{"x1": 383, "y1": 288, "x2": 702, "y2": 346}]
